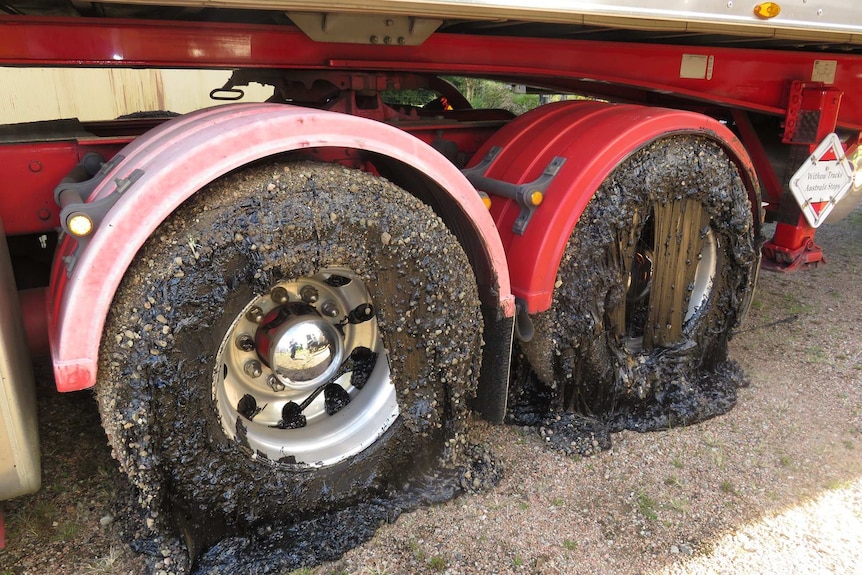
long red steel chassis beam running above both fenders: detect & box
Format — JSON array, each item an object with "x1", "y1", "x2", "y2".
[{"x1": 5, "y1": 16, "x2": 862, "y2": 129}]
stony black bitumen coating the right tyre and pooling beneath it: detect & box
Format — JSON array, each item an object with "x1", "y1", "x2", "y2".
[{"x1": 508, "y1": 136, "x2": 759, "y2": 454}]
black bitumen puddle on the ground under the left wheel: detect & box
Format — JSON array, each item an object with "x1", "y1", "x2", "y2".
[{"x1": 116, "y1": 445, "x2": 503, "y2": 575}]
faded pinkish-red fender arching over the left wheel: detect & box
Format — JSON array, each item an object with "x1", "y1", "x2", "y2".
[{"x1": 49, "y1": 104, "x2": 515, "y2": 391}]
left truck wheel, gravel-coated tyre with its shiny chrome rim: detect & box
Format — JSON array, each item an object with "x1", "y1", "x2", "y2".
[{"x1": 97, "y1": 161, "x2": 482, "y2": 531}]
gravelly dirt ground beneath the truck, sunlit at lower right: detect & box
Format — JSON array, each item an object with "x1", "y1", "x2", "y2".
[{"x1": 0, "y1": 209, "x2": 862, "y2": 575}]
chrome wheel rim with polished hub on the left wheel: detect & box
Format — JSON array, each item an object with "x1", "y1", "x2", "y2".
[{"x1": 213, "y1": 268, "x2": 399, "y2": 467}]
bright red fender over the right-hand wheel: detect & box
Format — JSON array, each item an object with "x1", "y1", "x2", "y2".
[{"x1": 472, "y1": 101, "x2": 760, "y2": 313}]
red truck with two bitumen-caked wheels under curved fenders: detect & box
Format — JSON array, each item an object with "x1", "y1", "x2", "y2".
[{"x1": 0, "y1": 0, "x2": 862, "y2": 560}]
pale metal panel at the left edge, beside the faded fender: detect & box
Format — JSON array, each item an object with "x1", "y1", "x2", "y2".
[{"x1": 0, "y1": 221, "x2": 41, "y2": 499}]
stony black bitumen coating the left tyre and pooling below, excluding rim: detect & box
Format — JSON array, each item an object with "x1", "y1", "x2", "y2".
[{"x1": 97, "y1": 162, "x2": 490, "y2": 573}]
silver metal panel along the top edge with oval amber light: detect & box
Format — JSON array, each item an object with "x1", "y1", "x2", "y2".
[{"x1": 104, "y1": 0, "x2": 862, "y2": 42}]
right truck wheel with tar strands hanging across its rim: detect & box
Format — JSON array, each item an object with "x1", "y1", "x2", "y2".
[{"x1": 522, "y1": 135, "x2": 759, "y2": 428}]
